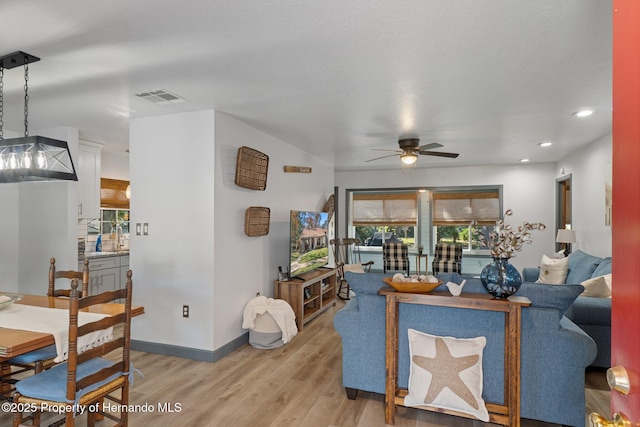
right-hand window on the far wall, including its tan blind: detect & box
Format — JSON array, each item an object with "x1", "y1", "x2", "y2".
[{"x1": 432, "y1": 189, "x2": 501, "y2": 250}]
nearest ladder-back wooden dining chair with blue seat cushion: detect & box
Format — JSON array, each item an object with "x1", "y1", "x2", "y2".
[{"x1": 13, "y1": 270, "x2": 133, "y2": 427}]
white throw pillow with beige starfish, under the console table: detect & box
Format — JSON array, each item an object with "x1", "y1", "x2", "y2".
[{"x1": 404, "y1": 329, "x2": 489, "y2": 422}]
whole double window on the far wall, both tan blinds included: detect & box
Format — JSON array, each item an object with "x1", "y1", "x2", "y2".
[{"x1": 346, "y1": 186, "x2": 502, "y2": 255}]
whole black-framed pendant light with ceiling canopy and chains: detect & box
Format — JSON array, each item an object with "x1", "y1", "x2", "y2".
[{"x1": 0, "y1": 52, "x2": 78, "y2": 183}]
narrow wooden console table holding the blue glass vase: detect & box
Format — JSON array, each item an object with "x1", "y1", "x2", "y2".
[{"x1": 378, "y1": 287, "x2": 531, "y2": 427}]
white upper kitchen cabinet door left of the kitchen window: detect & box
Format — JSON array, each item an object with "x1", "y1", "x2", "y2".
[{"x1": 78, "y1": 142, "x2": 101, "y2": 219}]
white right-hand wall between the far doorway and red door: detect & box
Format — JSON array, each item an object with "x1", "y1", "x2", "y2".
[{"x1": 556, "y1": 134, "x2": 612, "y2": 257}]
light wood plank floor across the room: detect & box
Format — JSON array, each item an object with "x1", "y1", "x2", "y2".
[{"x1": 0, "y1": 301, "x2": 609, "y2": 427}]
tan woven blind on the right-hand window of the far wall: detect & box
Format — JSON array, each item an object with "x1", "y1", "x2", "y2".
[{"x1": 432, "y1": 190, "x2": 500, "y2": 225}]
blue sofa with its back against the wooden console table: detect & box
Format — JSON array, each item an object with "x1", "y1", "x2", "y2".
[{"x1": 334, "y1": 273, "x2": 597, "y2": 426}]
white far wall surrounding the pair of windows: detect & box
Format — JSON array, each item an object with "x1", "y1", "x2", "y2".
[{"x1": 335, "y1": 164, "x2": 556, "y2": 271}]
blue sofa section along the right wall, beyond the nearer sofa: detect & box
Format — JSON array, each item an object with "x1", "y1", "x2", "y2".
[{"x1": 522, "y1": 250, "x2": 611, "y2": 368}]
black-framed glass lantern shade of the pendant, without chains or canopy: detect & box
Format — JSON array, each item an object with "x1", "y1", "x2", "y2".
[{"x1": 0, "y1": 136, "x2": 78, "y2": 183}]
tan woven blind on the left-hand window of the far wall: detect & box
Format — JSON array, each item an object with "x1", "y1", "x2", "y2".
[{"x1": 353, "y1": 193, "x2": 418, "y2": 226}]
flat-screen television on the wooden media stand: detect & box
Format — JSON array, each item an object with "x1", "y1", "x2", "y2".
[{"x1": 289, "y1": 211, "x2": 329, "y2": 277}]
